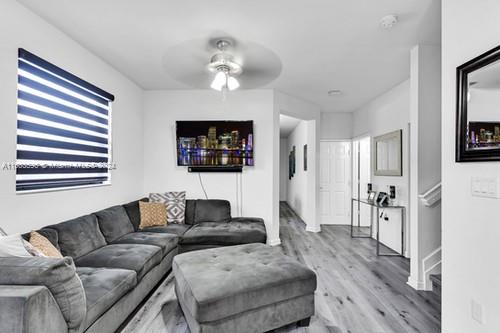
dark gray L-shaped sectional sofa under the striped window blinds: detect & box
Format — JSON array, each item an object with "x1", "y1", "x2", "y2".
[{"x1": 0, "y1": 199, "x2": 266, "y2": 333}]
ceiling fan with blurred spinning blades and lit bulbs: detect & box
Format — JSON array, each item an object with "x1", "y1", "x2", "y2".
[{"x1": 163, "y1": 36, "x2": 282, "y2": 92}]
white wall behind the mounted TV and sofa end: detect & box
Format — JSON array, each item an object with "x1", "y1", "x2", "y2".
[{"x1": 144, "y1": 90, "x2": 279, "y2": 242}]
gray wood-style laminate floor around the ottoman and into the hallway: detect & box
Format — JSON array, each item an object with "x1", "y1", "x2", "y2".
[{"x1": 122, "y1": 203, "x2": 441, "y2": 333}]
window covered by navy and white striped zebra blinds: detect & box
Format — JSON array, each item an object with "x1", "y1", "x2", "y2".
[{"x1": 16, "y1": 49, "x2": 114, "y2": 193}]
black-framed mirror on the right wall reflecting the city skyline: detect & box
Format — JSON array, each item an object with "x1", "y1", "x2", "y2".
[{"x1": 455, "y1": 46, "x2": 500, "y2": 162}]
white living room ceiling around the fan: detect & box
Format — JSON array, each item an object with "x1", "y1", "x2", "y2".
[{"x1": 18, "y1": 0, "x2": 441, "y2": 111}]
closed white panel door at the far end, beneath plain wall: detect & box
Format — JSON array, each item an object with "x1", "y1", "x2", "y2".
[{"x1": 319, "y1": 141, "x2": 351, "y2": 224}]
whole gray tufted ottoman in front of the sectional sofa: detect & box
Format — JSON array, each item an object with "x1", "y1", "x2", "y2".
[{"x1": 173, "y1": 244, "x2": 316, "y2": 333}]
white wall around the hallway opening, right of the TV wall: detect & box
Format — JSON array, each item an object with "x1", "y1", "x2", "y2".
[{"x1": 274, "y1": 91, "x2": 321, "y2": 232}]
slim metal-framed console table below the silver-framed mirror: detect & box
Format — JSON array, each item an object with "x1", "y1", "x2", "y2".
[{"x1": 351, "y1": 198, "x2": 406, "y2": 257}]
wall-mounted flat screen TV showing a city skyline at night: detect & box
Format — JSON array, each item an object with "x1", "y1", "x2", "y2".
[{"x1": 176, "y1": 120, "x2": 254, "y2": 167}]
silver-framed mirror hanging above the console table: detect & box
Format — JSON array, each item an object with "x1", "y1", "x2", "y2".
[{"x1": 372, "y1": 130, "x2": 403, "y2": 176}]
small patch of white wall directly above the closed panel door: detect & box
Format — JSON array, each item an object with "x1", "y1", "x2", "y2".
[{"x1": 320, "y1": 112, "x2": 353, "y2": 140}]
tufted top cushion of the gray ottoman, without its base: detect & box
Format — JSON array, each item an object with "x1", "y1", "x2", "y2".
[{"x1": 173, "y1": 244, "x2": 316, "y2": 323}]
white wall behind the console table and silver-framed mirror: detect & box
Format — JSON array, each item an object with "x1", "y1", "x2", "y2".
[{"x1": 353, "y1": 80, "x2": 410, "y2": 254}]
